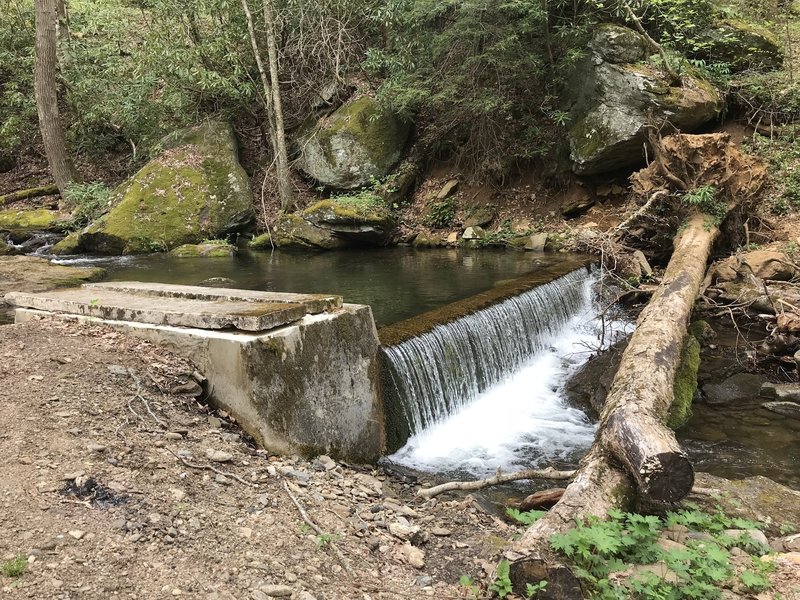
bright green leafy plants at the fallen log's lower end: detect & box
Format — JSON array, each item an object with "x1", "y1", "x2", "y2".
[{"x1": 506, "y1": 508, "x2": 773, "y2": 600}]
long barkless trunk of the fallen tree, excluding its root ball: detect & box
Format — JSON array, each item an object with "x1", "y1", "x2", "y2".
[{"x1": 507, "y1": 214, "x2": 718, "y2": 598}]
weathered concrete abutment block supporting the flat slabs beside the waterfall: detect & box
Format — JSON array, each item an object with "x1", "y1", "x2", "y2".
[{"x1": 9, "y1": 283, "x2": 386, "y2": 462}]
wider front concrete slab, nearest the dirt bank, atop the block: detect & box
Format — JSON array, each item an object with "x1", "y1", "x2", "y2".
[{"x1": 5, "y1": 286, "x2": 307, "y2": 331}]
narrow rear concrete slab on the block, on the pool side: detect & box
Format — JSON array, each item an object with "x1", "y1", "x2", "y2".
[{"x1": 85, "y1": 281, "x2": 342, "y2": 315}]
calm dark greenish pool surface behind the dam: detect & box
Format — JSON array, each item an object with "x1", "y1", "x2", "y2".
[{"x1": 51, "y1": 248, "x2": 583, "y2": 326}]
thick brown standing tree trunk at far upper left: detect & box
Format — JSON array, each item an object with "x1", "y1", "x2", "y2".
[{"x1": 34, "y1": 0, "x2": 77, "y2": 195}]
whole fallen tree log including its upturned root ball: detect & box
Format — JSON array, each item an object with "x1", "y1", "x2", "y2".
[{"x1": 506, "y1": 134, "x2": 764, "y2": 598}]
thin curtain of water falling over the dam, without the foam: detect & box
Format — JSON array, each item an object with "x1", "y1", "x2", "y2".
[{"x1": 383, "y1": 268, "x2": 596, "y2": 435}]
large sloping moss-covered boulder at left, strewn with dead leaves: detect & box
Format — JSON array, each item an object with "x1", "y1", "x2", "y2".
[{"x1": 52, "y1": 122, "x2": 255, "y2": 255}]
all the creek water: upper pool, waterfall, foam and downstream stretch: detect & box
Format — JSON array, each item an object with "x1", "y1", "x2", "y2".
[{"x1": 10, "y1": 248, "x2": 800, "y2": 488}]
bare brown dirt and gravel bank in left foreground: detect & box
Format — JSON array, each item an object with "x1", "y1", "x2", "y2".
[{"x1": 0, "y1": 320, "x2": 517, "y2": 600}]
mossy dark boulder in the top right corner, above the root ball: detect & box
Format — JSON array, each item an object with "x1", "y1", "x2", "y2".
[{"x1": 695, "y1": 19, "x2": 783, "y2": 73}]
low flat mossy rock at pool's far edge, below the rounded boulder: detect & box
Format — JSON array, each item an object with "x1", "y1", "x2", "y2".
[{"x1": 303, "y1": 199, "x2": 397, "y2": 246}]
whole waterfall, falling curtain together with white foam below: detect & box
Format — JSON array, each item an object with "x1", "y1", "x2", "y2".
[{"x1": 386, "y1": 269, "x2": 622, "y2": 477}]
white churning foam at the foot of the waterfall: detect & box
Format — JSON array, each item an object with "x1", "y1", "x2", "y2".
[{"x1": 389, "y1": 304, "x2": 625, "y2": 477}]
